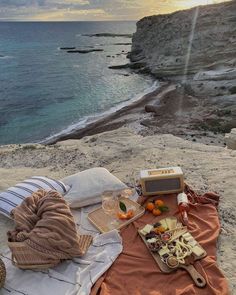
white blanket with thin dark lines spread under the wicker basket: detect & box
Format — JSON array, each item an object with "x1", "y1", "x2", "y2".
[{"x1": 0, "y1": 205, "x2": 123, "y2": 295}]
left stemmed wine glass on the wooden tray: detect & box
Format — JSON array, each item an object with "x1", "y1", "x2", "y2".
[{"x1": 102, "y1": 191, "x2": 119, "y2": 229}]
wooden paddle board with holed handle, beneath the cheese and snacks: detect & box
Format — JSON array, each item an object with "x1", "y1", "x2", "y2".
[{"x1": 138, "y1": 220, "x2": 207, "y2": 288}]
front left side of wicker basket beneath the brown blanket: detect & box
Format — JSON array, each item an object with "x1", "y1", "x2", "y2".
[{"x1": 8, "y1": 242, "x2": 60, "y2": 269}]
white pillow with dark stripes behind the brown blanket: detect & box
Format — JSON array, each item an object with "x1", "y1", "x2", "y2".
[{"x1": 0, "y1": 176, "x2": 70, "y2": 217}]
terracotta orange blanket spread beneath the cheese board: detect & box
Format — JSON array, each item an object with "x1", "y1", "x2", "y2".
[{"x1": 91, "y1": 186, "x2": 229, "y2": 295}]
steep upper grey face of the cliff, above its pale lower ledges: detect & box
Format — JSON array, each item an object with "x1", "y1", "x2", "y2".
[{"x1": 130, "y1": 0, "x2": 236, "y2": 80}]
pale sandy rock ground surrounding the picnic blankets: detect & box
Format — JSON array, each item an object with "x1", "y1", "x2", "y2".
[{"x1": 0, "y1": 127, "x2": 236, "y2": 294}]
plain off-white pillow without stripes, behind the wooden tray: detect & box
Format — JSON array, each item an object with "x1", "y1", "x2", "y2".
[{"x1": 62, "y1": 167, "x2": 127, "y2": 208}]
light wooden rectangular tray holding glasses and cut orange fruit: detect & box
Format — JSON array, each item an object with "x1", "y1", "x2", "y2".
[{"x1": 88, "y1": 198, "x2": 145, "y2": 233}]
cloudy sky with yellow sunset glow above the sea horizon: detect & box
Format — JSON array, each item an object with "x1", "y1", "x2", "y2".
[{"x1": 0, "y1": 0, "x2": 230, "y2": 21}]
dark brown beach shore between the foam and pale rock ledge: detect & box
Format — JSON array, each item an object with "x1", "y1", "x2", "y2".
[{"x1": 44, "y1": 81, "x2": 225, "y2": 146}]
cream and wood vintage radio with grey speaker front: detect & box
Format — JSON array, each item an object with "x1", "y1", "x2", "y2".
[{"x1": 139, "y1": 167, "x2": 184, "y2": 196}]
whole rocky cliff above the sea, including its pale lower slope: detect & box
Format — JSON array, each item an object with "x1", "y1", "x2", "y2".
[{"x1": 129, "y1": 0, "x2": 236, "y2": 132}]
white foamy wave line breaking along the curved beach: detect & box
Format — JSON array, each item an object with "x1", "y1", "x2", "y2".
[{"x1": 38, "y1": 81, "x2": 160, "y2": 144}]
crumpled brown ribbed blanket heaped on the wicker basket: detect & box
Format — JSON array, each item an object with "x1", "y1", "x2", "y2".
[{"x1": 8, "y1": 190, "x2": 92, "y2": 259}]
